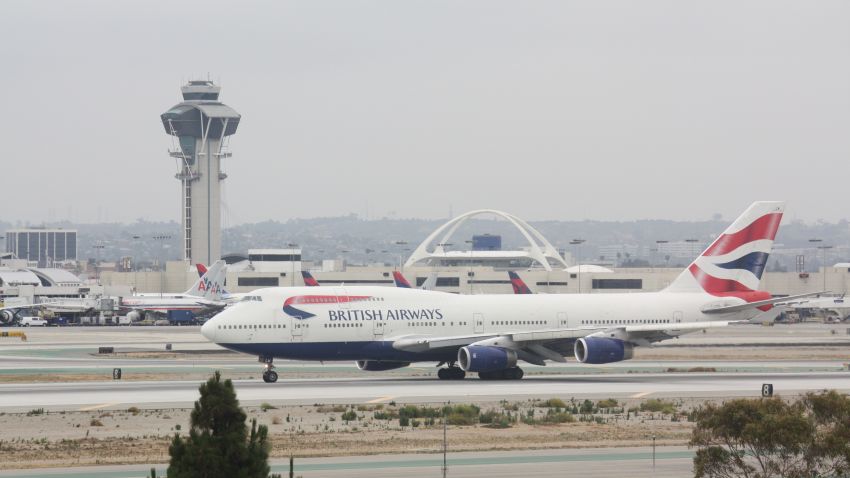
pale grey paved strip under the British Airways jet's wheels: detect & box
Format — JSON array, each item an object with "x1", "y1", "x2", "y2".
[{"x1": 0, "y1": 372, "x2": 850, "y2": 412}]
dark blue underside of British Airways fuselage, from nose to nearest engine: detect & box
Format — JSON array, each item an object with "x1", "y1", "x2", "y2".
[{"x1": 218, "y1": 341, "x2": 458, "y2": 362}]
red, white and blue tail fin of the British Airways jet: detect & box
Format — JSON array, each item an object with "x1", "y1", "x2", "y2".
[{"x1": 665, "y1": 201, "x2": 785, "y2": 302}]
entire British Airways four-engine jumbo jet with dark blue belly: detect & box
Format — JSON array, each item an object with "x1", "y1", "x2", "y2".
[{"x1": 201, "y1": 201, "x2": 808, "y2": 382}]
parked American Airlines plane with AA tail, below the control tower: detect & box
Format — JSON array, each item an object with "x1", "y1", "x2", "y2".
[{"x1": 118, "y1": 260, "x2": 226, "y2": 314}]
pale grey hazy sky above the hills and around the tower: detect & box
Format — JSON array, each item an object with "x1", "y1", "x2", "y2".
[{"x1": 0, "y1": 0, "x2": 850, "y2": 225}]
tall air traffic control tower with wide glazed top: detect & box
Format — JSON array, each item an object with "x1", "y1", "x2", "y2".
[{"x1": 161, "y1": 80, "x2": 241, "y2": 265}]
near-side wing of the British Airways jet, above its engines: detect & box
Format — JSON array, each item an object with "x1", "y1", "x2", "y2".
[{"x1": 393, "y1": 321, "x2": 731, "y2": 365}]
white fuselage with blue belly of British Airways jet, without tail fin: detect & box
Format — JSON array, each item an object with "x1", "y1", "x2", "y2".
[{"x1": 202, "y1": 287, "x2": 759, "y2": 362}]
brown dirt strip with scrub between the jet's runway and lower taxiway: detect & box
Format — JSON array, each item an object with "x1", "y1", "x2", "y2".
[{"x1": 0, "y1": 400, "x2": 697, "y2": 469}]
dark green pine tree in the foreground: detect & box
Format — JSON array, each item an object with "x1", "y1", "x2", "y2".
[{"x1": 167, "y1": 372, "x2": 270, "y2": 478}]
